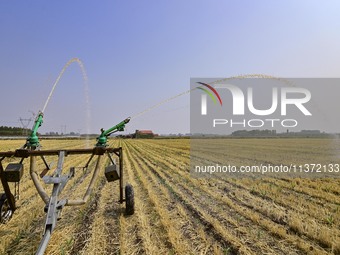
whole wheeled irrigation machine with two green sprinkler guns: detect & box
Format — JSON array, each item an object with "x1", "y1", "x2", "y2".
[{"x1": 0, "y1": 112, "x2": 134, "y2": 254}]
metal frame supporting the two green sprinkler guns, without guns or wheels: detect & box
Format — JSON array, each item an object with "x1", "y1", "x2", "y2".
[{"x1": 0, "y1": 146, "x2": 125, "y2": 254}]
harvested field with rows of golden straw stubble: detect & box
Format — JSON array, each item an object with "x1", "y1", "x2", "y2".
[{"x1": 0, "y1": 139, "x2": 340, "y2": 255}]
